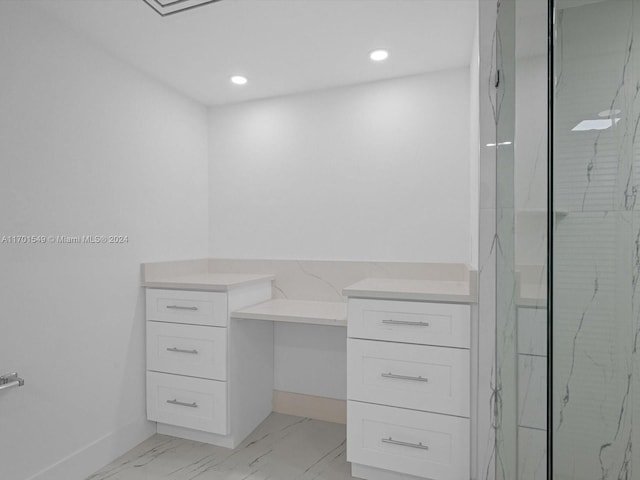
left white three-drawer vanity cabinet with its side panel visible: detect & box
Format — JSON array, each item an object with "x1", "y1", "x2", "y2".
[{"x1": 146, "y1": 278, "x2": 273, "y2": 448}]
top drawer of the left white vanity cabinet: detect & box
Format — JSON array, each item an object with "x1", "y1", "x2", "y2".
[{"x1": 147, "y1": 288, "x2": 228, "y2": 327}]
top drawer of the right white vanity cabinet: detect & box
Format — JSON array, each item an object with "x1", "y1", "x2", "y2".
[{"x1": 347, "y1": 298, "x2": 471, "y2": 348}]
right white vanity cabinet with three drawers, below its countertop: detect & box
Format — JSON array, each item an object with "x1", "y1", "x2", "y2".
[{"x1": 347, "y1": 298, "x2": 471, "y2": 480}]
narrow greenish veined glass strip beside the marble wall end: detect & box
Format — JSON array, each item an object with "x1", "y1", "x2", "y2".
[{"x1": 496, "y1": 0, "x2": 518, "y2": 480}]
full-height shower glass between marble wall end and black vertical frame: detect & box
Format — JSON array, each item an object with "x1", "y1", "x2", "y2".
[{"x1": 492, "y1": 0, "x2": 548, "y2": 480}]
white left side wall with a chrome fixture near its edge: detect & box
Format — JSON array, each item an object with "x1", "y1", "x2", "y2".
[{"x1": 0, "y1": 1, "x2": 208, "y2": 480}]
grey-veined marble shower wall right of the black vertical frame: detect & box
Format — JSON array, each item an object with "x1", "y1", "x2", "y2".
[{"x1": 553, "y1": 0, "x2": 640, "y2": 480}]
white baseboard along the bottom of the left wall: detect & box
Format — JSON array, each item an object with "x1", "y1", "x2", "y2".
[{"x1": 26, "y1": 419, "x2": 156, "y2": 480}]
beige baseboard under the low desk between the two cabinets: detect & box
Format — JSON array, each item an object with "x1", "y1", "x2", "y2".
[{"x1": 273, "y1": 390, "x2": 347, "y2": 424}]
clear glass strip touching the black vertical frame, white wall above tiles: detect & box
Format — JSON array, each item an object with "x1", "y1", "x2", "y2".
[{"x1": 511, "y1": 0, "x2": 548, "y2": 480}]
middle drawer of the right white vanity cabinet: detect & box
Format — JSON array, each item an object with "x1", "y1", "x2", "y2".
[{"x1": 347, "y1": 338, "x2": 471, "y2": 417}]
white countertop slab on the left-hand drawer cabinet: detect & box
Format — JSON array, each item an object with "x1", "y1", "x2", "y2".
[{"x1": 142, "y1": 273, "x2": 275, "y2": 292}]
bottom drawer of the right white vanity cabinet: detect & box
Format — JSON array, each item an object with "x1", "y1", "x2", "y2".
[{"x1": 347, "y1": 400, "x2": 470, "y2": 480}]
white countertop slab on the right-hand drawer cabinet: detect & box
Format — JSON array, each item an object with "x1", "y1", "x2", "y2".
[{"x1": 342, "y1": 278, "x2": 477, "y2": 303}]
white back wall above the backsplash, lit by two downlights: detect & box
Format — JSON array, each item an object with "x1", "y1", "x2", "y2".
[{"x1": 209, "y1": 69, "x2": 472, "y2": 263}]
